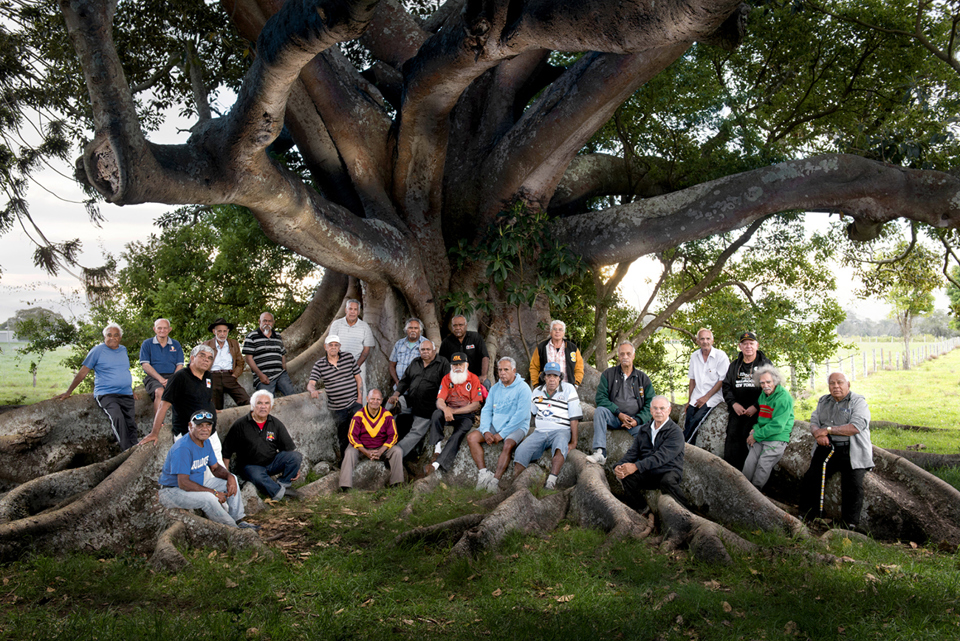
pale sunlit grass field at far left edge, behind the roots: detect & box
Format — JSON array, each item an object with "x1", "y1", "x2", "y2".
[{"x1": 0, "y1": 343, "x2": 75, "y2": 405}]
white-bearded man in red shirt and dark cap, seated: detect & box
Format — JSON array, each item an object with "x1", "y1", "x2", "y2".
[{"x1": 424, "y1": 352, "x2": 482, "y2": 476}]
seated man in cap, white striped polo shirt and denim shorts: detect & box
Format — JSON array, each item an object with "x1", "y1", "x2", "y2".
[{"x1": 513, "y1": 362, "x2": 583, "y2": 490}]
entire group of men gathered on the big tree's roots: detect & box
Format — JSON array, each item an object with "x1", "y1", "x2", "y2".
[{"x1": 60, "y1": 300, "x2": 873, "y2": 526}]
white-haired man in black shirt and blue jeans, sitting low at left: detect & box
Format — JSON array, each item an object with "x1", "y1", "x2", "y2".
[{"x1": 223, "y1": 390, "x2": 303, "y2": 501}]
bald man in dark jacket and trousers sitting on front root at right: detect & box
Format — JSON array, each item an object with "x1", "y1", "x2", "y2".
[{"x1": 613, "y1": 396, "x2": 689, "y2": 509}]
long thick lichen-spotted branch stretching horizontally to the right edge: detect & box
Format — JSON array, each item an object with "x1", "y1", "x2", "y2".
[{"x1": 553, "y1": 154, "x2": 960, "y2": 266}]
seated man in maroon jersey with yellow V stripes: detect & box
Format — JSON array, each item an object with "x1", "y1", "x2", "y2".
[{"x1": 340, "y1": 388, "x2": 403, "y2": 492}]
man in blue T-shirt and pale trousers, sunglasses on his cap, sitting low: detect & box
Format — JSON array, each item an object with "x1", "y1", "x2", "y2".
[{"x1": 159, "y1": 409, "x2": 260, "y2": 530}]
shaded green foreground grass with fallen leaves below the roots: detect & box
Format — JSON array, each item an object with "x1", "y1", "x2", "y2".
[{"x1": 0, "y1": 488, "x2": 960, "y2": 641}]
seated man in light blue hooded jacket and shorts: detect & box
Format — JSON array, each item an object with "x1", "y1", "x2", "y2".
[{"x1": 467, "y1": 356, "x2": 530, "y2": 492}]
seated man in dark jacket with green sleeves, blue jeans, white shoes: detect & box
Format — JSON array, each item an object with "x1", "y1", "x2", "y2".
[{"x1": 587, "y1": 341, "x2": 654, "y2": 465}]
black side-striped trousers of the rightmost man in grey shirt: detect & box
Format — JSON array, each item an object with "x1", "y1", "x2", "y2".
[{"x1": 799, "y1": 443, "x2": 868, "y2": 527}]
